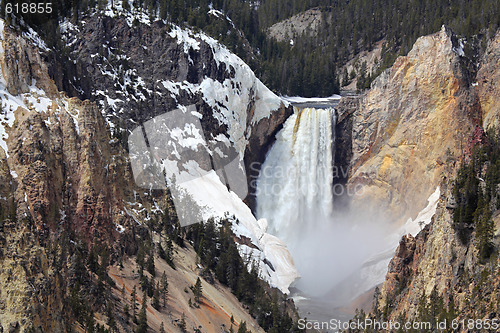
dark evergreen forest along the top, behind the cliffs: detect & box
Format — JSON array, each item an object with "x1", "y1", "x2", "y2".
[{"x1": 2, "y1": 0, "x2": 500, "y2": 96}]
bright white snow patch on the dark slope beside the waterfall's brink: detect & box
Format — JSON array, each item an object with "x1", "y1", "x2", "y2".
[{"x1": 162, "y1": 25, "x2": 288, "y2": 157}]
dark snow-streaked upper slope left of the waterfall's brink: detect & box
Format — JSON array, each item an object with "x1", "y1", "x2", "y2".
[{"x1": 61, "y1": 2, "x2": 288, "y2": 154}]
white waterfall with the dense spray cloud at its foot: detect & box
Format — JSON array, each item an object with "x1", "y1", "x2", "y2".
[{"x1": 256, "y1": 108, "x2": 385, "y2": 296}]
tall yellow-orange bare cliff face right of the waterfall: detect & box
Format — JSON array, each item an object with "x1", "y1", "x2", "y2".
[{"x1": 350, "y1": 28, "x2": 481, "y2": 221}]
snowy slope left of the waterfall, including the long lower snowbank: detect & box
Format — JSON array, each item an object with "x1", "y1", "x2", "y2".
[{"x1": 57, "y1": 1, "x2": 298, "y2": 292}]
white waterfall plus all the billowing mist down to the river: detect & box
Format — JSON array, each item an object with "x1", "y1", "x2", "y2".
[{"x1": 256, "y1": 104, "x2": 400, "y2": 319}]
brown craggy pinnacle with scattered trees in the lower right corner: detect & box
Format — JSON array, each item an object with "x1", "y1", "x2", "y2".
[{"x1": 375, "y1": 172, "x2": 500, "y2": 322}]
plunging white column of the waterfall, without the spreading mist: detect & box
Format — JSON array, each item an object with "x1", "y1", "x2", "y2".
[{"x1": 256, "y1": 108, "x2": 336, "y2": 291}]
